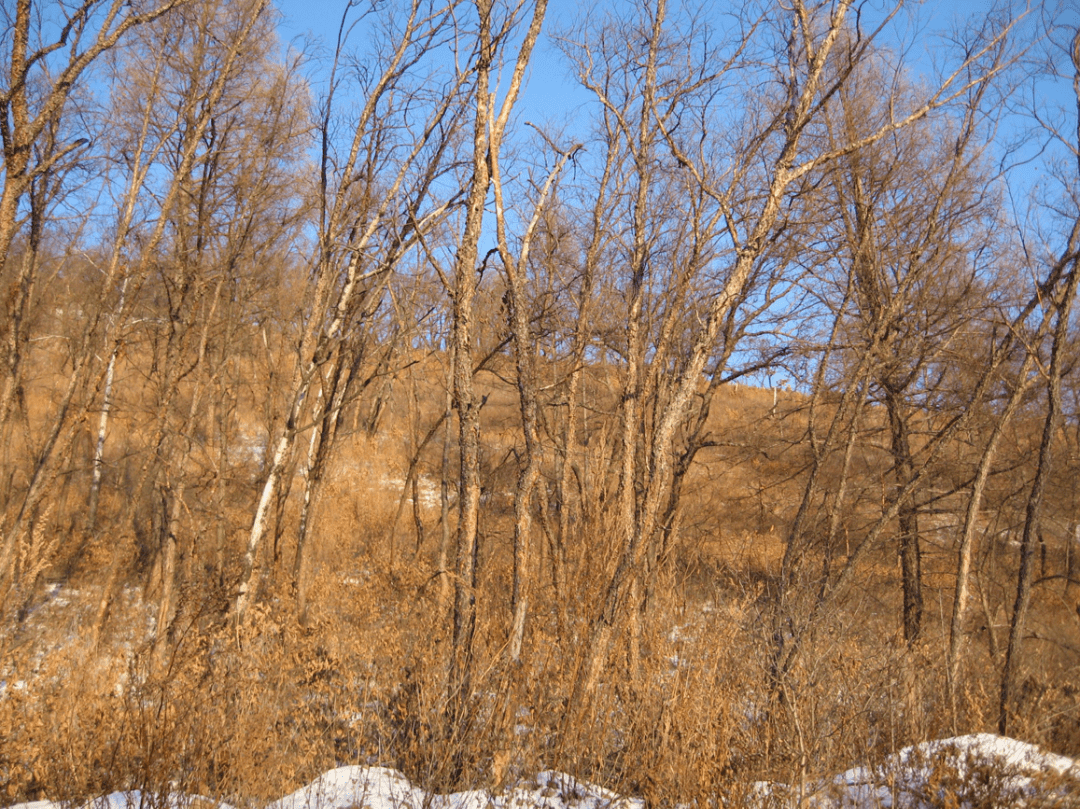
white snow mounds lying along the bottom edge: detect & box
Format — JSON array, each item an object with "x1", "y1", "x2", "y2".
[{"x1": 12, "y1": 733, "x2": 1080, "y2": 809}]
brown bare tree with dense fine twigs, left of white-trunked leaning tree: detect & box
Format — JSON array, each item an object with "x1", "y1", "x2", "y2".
[{"x1": 128, "y1": 2, "x2": 306, "y2": 652}]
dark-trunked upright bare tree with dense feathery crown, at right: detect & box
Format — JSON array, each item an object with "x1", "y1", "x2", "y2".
[{"x1": 812, "y1": 63, "x2": 996, "y2": 643}]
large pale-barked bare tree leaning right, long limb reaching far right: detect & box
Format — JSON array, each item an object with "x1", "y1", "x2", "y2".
[{"x1": 552, "y1": 2, "x2": 1023, "y2": 713}]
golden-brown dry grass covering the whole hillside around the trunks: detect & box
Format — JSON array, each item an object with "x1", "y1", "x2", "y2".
[{"x1": 0, "y1": 349, "x2": 1080, "y2": 806}]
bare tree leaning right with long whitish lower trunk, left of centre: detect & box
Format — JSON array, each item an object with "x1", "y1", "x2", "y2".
[{"x1": 234, "y1": 0, "x2": 470, "y2": 618}]
